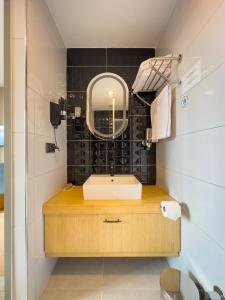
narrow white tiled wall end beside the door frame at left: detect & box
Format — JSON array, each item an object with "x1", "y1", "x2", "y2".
[{"x1": 10, "y1": 0, "x2": 27, "y2": 300}]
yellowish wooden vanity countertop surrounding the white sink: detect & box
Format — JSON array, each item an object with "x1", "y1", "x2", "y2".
[{"x1": 43, "y1": 186, "x2": 173, "y2": 215}]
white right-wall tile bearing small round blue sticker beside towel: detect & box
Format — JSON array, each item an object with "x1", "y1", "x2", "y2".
[{"x1": 176, "y1": 64, "x2": 225, "y2": 134}]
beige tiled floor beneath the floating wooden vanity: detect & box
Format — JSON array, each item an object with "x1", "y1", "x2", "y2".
[{"x1": 41, "y1": 258, "x2": 168, "y2": 300}]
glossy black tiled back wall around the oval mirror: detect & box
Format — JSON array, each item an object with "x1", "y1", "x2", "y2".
[{"x1": 67, "y1": 48, "x2": 156, "y2": 185}]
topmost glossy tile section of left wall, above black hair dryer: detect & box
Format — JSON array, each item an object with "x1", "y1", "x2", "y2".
[{"x1": 27, "y1": 0, "x2": 66, "y2": 101}]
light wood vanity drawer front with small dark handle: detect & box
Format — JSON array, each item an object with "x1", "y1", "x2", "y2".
[{"x1": 45, "y1": 214, "x2": 180, "y2": 256}]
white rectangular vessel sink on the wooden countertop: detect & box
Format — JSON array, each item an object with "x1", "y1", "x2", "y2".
[{"x1": 83, "y1": 175, "x2": 142, "y2": 200}]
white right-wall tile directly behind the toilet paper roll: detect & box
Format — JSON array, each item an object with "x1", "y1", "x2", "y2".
[{"x1": 160, "y1": 166, "x2": 225, "y2": 249}]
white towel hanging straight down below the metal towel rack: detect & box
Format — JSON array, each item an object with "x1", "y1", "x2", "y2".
[{"x1": 151, "y1": 85, "x2": 171, "y2": 143}]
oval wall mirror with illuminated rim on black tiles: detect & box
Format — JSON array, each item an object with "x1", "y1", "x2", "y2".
[{"x1": 86, "y1": 73, "x2": 129, "y2": 139}]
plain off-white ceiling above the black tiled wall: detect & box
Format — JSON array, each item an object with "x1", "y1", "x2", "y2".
[{"x1": 45, "y1": 0, "x2": 176, "y2": 48}]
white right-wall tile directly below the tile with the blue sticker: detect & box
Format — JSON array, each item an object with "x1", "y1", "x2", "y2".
[{"x1": 157, "y1": 126, "x2": 225, "y2": 187}]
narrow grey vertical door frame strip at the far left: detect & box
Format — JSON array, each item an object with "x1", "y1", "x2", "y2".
[{"x1": 4, "y1": 0, "x2": 13, "y2": 299}]
